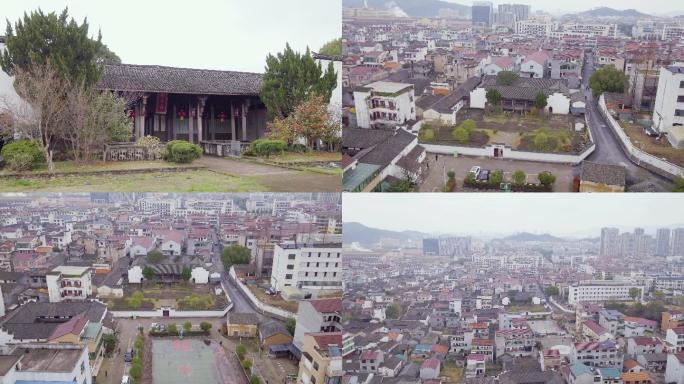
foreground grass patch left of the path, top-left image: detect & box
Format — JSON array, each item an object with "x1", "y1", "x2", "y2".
[{"x1": 0, "y1": 170, "x2": 269, "y2": 192}]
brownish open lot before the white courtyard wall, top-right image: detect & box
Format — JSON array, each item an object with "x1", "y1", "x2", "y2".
[{"x1": 420, "y1": 154, "x2": 579, "y2": 192}]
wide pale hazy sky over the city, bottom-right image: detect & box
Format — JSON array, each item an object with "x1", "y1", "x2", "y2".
[{"x1": 342, "y1": 193, "x2": 684, "y2": 236}]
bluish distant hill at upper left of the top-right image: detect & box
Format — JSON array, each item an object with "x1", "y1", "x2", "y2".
[{"x1": 342, "y1": 0, "x2": 470, "y2": 17}]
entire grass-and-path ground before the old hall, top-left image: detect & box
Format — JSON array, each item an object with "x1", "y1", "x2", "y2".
[{"x1": 0, "y1": 156, "x2": 341, "y2": 192}]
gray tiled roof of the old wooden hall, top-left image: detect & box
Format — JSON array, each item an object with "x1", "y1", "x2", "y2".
[{"x1": 98, "y1": 64, "x2": 263, "y2": 95}]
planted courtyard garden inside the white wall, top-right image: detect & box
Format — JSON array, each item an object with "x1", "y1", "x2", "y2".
[{"x1": 421, "y1": 109, "x2": 590, "y2": 153}]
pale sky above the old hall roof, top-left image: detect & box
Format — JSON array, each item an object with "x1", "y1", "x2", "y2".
[{"x1": 0, "y1": 0, "x2": 342, "y2": 72}]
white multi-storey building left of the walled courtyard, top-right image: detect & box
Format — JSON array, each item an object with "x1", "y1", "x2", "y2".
[{"x1": 354, "y1": 81, "x2": 416, "y2": 128}]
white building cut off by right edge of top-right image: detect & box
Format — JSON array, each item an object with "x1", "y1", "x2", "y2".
[{"x1": 653, "y1": 63, "x2": 684, "y2": 148}]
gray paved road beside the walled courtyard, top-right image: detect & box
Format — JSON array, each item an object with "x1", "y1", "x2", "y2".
[{"x1": 582, "y1": 55, "x2": 672, "y2": 190}]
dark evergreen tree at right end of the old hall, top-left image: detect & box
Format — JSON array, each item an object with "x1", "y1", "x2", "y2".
[{"x1": 260, "y1": 44, "x2": 337, "y2": 118}]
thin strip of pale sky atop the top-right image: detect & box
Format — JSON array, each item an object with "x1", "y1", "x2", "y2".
[{"x1": 446, "y1": 0, "x2": 684, "y2": 14}]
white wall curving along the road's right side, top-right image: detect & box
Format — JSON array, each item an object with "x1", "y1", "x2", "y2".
[{"x1": 598, "y1": 95, "x2": 684, "y2": 179}]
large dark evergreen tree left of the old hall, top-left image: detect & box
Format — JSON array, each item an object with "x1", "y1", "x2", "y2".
[{"x1": 0, "y1": 8, "x2": 120, "y2": 87}]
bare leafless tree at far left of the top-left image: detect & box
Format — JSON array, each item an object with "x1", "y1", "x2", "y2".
[{"x1": 2, "y1": 65, "x2": 69, "y2": 172}]
